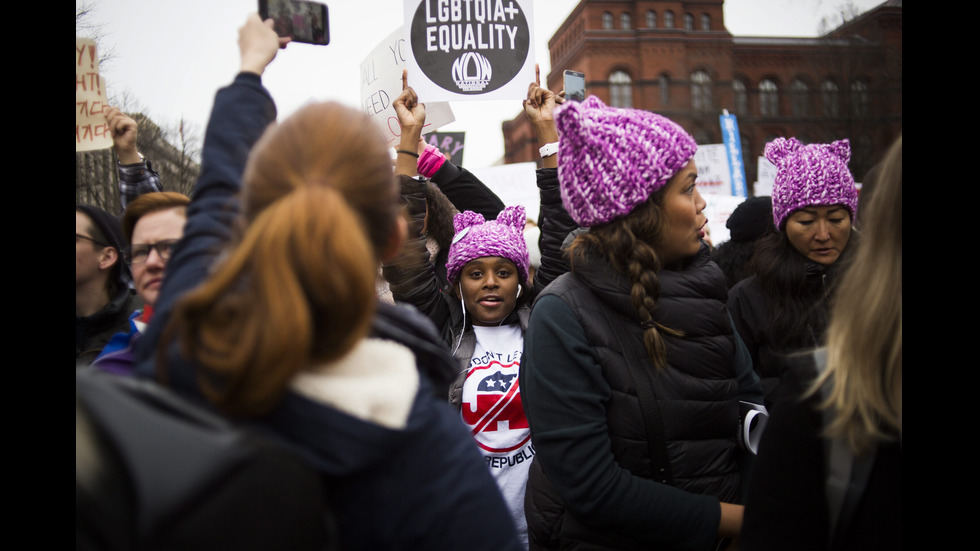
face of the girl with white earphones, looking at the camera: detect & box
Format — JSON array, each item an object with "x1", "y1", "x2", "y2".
[{"x1": 459, "y1": 256, "x2": 520, "y2": 325}]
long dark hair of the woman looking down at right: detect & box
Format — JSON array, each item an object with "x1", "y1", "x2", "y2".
[{"x1": 749, "y1": 229, "x2": 859, "y2": 350}]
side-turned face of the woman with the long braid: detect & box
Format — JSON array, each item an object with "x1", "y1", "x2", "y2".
[{"x1": 658, "y1": 160, "x2": 708, "y2": 264}]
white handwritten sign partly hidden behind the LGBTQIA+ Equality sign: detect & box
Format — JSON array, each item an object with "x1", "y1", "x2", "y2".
[{"x1": 361, "y1": 28, "x2": 456, "y2": 146}]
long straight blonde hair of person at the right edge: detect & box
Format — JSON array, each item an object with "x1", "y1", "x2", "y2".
[{"x1": 808, "y1": 136, "x2": 902, "y2": 453}]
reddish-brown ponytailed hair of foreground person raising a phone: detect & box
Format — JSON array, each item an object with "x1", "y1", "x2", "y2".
[{"x1": 165, "y1": 103, "x2": 400, "y2": 417}]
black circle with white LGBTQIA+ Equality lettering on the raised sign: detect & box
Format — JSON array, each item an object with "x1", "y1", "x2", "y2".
[{"x1": 411, "y1": 0, "x2": 531, "y2": 94}]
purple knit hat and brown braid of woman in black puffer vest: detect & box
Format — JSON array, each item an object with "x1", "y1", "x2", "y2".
[{"x1": 555, "y1": 96, "x2": 697, "y2": 367}]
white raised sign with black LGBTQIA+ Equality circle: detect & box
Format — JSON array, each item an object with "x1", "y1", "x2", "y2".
[{"x1": 405, "y1": 0, "x2": 534, "y2": 101}]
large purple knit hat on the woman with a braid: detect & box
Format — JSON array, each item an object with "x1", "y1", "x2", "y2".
[{"x1": 555, "y1": 96, "x2": 698, "y2": 227}]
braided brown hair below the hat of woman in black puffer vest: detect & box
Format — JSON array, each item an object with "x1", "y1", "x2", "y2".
[{"x1": 569, "y1": 186, "x2": 682, "y2": 368}]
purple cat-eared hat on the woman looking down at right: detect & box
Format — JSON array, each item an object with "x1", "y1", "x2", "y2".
[{"x1": 766, "y1": 138, "x2": 857, "y2": 230}]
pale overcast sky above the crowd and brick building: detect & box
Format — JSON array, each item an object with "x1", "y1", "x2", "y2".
[{"x1": 75, "y1": 0, "x2": 883, "y2": 167}]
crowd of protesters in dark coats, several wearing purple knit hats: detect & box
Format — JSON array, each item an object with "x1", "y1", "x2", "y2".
[{"x1": 75, "y1": 14, "x2": 902, "y2": 550}]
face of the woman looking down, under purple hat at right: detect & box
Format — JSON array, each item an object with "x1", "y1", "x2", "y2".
[{"x1": 786, "y1": 205, "x2": 851, "y2": 266}]
